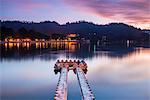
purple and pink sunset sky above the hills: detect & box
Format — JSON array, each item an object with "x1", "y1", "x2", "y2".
[{"x1": 0, "y1": 0, "x2": 150, "y2": 29}]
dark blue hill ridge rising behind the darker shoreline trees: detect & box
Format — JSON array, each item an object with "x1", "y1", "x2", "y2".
[{"x1": 0, "y1": 21, "x2": 149, "y2": 41}]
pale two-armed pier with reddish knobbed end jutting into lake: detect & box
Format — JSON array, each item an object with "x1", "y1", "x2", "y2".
[{"x1": 54, "y1": 60, "x2": 95, "y2": 100}]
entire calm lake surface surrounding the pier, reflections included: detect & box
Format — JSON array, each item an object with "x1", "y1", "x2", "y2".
[{"x1": 0, "y1": 42, "x2": 150, "y2": 100}]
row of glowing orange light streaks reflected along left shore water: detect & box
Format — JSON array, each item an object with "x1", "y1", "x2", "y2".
[{"x1": 4, "y1": 39, "x2": 80, "y2": 52}]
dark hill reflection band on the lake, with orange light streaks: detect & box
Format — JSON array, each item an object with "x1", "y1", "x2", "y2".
[{"x1": 0, "y1": 42, "x2": 148, "y2": 61}]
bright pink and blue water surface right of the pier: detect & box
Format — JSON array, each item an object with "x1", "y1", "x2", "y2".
[{"x1": 86, "y1": 48, "x2": 150, "y2": 100}]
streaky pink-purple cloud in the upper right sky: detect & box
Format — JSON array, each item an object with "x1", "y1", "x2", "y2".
[{"x1": 64, "y1": 0, "x2": 150, "y2": 28}]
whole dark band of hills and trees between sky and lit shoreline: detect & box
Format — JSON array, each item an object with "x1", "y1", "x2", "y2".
[{"x1": 0, "y1": 21, "x2": 150, "y2": 42}]
